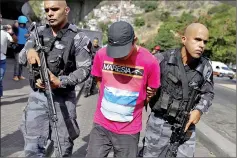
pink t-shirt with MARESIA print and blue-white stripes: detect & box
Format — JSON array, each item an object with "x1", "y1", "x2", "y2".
[{"x1": 92, "y1": 47, "x2": 160, "y2": 134}]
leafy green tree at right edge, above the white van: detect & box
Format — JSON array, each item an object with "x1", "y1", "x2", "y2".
[{"x1": 203, "y1": 5, "x2": 236, "y2": 63}]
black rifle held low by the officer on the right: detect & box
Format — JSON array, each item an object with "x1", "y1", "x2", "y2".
[{"x1": 161, "y1": 87, "x2": 199, "y2": 157}]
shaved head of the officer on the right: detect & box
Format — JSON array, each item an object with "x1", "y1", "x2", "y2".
[{"x1": 182, "y1": 23, "x2": 209, "y2": 58}]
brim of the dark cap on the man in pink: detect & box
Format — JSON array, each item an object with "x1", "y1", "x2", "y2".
[{"x1": 106, "y1": 42, "x2": 132, "y2": 58}]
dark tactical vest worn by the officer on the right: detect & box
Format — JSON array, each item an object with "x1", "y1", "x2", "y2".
[{"x1": 149, "y1": 50, "x2": 205, "y2": 117}]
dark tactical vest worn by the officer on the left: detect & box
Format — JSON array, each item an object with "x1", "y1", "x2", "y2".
[{"x1": 39, "y1": 25, "x2": 78, "y2": 76}]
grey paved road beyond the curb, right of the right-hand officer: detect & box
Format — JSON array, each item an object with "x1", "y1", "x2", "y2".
[{"x1": 202, "y1": 78, "x2": 236, "y2": 144}]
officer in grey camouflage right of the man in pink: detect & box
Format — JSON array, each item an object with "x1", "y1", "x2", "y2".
[{"x1": 143, "y1": 23, "x2": 214, "y2": 157}]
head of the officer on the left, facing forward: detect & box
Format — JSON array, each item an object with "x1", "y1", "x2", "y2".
[{"x1": 44, "y1": 0, "x2": 70, "y2": 28}]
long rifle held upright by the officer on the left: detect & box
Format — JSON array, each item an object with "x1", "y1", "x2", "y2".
[{"x1": 29, "y1": 22, "x2": 62, "y2": 157}]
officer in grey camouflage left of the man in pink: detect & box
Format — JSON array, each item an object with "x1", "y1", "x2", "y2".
[{"x1": 19, "y1": 0, "x2": 92, "y2": 157}]
